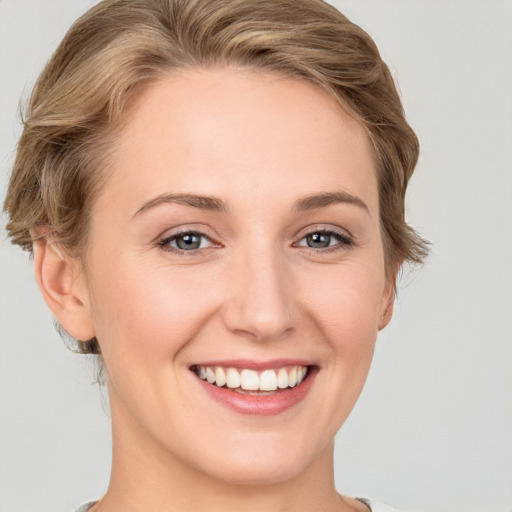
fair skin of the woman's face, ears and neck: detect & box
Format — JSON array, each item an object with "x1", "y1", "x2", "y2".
[{"x1": 35, "y1": 68, "x2": 394, "y2": 512}]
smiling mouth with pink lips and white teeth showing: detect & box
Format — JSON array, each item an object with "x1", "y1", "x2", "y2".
[{"x1": 190, "y1": 362, "x2": 318, "y2": 415}]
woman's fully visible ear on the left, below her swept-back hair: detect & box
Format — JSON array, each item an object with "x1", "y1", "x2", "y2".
[{"x1": 34, "y1": 237, "x2": 95, "y2": 341}]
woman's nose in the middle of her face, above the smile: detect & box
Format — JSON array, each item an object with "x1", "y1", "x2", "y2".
[{"x1": 223, "y1": 246, "x2": 299, "y2": 342}]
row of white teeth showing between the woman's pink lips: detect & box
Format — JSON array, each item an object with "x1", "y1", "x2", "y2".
[{"x1": 195, "y1": 366, "x2": 308, "y2": 394}]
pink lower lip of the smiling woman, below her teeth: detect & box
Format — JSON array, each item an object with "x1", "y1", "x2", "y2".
[{"x1": 194, "y1": 369, "x2": 317, "y2": 416}]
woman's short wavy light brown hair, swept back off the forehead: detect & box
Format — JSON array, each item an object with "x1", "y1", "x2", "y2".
[{"x1": 4, "y1": 0, "x2": 427, "y2": 352}]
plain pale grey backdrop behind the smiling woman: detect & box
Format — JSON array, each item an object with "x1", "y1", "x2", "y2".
[{"x1": 0, "y1": 0, "x2": 512, "y2": 512}]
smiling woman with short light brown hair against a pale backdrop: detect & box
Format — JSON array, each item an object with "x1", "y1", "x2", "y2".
[{"x1": 5, "y1": 0, "x2": 426, "y2": 512}]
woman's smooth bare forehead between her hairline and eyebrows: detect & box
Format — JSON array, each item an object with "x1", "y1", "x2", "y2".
[{"x1": 96, "y1": 68, "x2": 377, "y2": 216}]
